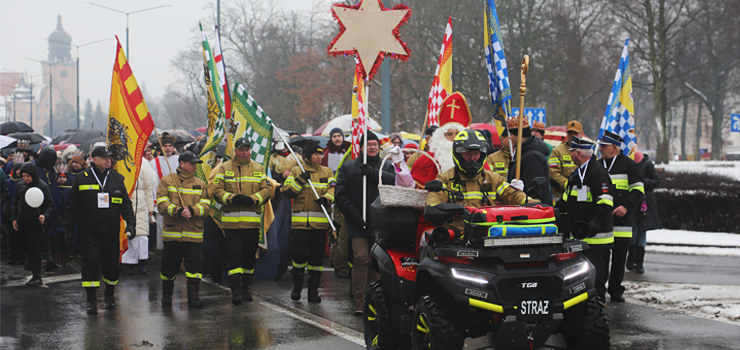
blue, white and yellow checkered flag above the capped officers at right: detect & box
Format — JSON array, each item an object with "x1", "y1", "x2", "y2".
[{"x1": 599, "y1": 39, "x2": 637, "y2": 156}]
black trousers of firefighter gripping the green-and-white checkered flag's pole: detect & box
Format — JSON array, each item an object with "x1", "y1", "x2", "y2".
[{"x1": 290, "y1": 230, "x2": 326, "y2": 271}]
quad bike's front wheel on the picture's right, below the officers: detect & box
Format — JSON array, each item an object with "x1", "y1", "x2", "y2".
[{"x1": 560, "y1": 298, "x2": 611, "y2": 350}]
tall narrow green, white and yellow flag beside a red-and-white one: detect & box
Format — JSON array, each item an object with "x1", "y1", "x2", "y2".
[{"x1": 195, "y1": 23, "x2": 226, "y2": 182}]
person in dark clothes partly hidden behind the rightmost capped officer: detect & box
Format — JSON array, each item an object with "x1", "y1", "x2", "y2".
[{"x1": 627, "y1": 151, "x2": 660, "y2": 274}]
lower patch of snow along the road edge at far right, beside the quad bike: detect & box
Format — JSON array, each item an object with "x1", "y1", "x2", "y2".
[{"x1": 623, "y1": 282, "x2": 740, "y2": 325}]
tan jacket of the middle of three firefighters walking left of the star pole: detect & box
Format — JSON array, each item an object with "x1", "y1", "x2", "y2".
[{"x1": 213, "y1": 158, "x2": 271, "y2": 230}]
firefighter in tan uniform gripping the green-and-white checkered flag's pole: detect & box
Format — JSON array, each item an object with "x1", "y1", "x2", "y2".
[{"x1": 282, "y1": 142, "x2": 337, "y2": 303}]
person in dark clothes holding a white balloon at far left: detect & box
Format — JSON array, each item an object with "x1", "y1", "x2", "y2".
[{"x1": 10, "y1": 163, "x2": 54, "y2": 286}]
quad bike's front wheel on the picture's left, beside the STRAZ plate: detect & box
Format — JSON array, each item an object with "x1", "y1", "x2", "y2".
[{"x1": 411, "y1": 295, "x2": 463, "y2": 350}]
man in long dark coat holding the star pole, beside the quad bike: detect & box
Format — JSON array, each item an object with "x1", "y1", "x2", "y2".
[{"x1": 335, "y1": 131, "x2": 396, "y2": 315}]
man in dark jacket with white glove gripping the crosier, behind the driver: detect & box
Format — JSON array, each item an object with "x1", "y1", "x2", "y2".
[{"x1": 506, "y1": 117, "x2": 552, "y2": 203}]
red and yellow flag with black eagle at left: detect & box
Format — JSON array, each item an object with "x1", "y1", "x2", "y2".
[{"x1": 108, "y1": 36, "x2": 154, "y2": 260}]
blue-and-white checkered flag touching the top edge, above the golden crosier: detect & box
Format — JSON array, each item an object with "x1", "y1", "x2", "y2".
[{"x1": 485, "y1": 0, "x2": 511, "y2": 123}]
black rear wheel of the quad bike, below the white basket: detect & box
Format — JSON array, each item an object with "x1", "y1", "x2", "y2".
[{"x1": 362, "y1": 281, "x2": 408, "y2": 350}]
